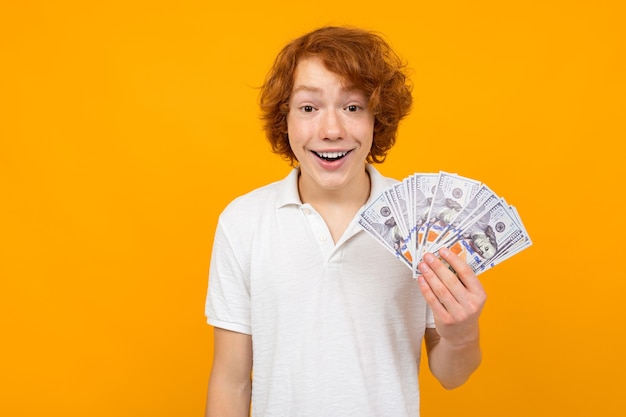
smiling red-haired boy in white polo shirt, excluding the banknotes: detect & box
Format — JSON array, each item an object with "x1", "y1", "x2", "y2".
[{"x1": 206, "y1": 27, "x2": 485, "y2": 417}]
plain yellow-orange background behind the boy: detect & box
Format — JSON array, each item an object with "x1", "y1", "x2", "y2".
[{"x1": 0, "y1": 0, "x2": 626, "y2": 417}]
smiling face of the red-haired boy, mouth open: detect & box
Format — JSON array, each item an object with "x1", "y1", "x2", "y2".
[{"x1": 287, "y1": 57, "x2": 374, "y2": 197}]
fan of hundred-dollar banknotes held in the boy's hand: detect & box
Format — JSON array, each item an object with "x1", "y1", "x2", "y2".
[{"x1": 359, "y1": 171, "x2": 532, "y2": 277}]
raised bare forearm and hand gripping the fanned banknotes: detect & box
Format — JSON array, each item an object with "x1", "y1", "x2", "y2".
[{"x1": 418, "y1": 248, "x2": 486, "y2": 389}]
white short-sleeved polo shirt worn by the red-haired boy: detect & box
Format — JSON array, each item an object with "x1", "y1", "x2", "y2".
[{"x1": 206, "y1": 165, "x2": 434, "y2": 417}]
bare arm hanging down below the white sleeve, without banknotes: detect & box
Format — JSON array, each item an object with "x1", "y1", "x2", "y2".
[{"x1": 205, "y1": 327, "x2": 252, "y2": 417}]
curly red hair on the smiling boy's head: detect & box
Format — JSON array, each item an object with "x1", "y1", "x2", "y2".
[{"x1": 259, "y1": 26, "x2": 413, "y2": 165}]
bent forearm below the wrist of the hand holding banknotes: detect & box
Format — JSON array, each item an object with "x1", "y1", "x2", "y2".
[{"x1": 428, "y1": 330, "x2": 482, "y2": 389}]
